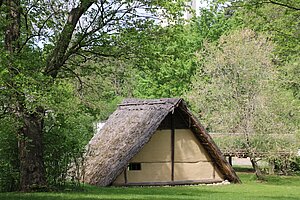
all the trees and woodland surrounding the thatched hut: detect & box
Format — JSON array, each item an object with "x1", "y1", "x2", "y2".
[{"x1": 0, "y1": 0, "x2": 300, "y2": 191}]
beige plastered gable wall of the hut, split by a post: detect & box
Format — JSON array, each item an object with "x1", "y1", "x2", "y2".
[{"x1": 113, "y1": 129, "x2": 223, "y2": 185}]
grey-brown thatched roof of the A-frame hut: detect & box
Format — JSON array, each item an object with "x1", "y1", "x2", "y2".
[{"x1": 84, "y1": 98, "x2": 240, "y2": 186}]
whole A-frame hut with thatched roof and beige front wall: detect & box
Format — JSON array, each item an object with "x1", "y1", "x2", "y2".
[{"x1": 83, "y1": 98, "x2": 240, "y2": 186}]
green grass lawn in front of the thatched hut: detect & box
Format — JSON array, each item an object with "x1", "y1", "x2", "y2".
[{"x1": 0, "y1": 173, "x2": 300, "y2": 200}]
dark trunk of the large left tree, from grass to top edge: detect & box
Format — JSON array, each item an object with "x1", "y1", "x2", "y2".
[{"x1": 1, "y1": 0, "x2": 46, "y2": 191}]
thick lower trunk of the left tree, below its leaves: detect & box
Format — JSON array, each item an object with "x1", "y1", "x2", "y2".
[{"x1": 19, "y1": 112, "x2": 46, "y2": 191}]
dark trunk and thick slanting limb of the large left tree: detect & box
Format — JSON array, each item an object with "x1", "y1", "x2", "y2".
[{"x1": 0, "y1": 0, "x2": 95, "y2": 191}]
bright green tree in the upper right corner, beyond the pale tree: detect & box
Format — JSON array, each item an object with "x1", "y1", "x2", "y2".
[{"x1": 205, "y1": 0, "x2": 300, "y2": 98}]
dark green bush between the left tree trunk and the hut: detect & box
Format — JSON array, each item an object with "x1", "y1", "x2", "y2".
[{"x1": 44, "y1": 81, "x2": 95, "y2": 187}]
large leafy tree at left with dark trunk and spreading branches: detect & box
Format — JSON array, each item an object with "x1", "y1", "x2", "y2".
[{"x1": 0, "y1": 0, "x2": 183, "y2": 191}]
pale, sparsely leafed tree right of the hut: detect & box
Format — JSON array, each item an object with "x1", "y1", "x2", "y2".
[{"x1": 188, "y1": 29, "x2": 299, "y2": 178}]
